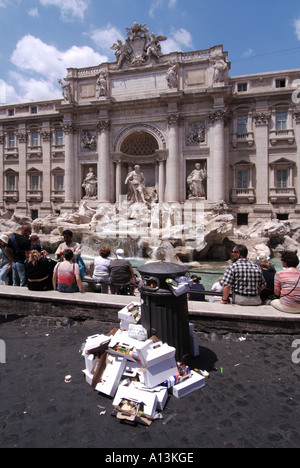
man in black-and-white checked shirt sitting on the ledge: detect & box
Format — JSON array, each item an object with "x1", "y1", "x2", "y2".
[{"x1": 220, "y1": 244, "x2": 266, "y2": 306}]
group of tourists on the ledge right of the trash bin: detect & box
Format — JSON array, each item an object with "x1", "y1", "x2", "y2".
[{"x1": 185, "y1": 244, "x2": 300, "y2": 314}]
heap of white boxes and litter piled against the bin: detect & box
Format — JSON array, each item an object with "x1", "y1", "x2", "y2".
[{"x1": 81, "y1": 302, "x2": 208, "y2": 425}]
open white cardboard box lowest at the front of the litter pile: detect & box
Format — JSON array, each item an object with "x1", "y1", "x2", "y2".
[{"x1": 113, "y1": 385, "x2": 157, "y2": 419}]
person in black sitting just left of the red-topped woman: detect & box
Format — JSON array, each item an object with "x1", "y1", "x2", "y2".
[{"x1": 25, "y1": 244, "x2": 53, "y2": 291}]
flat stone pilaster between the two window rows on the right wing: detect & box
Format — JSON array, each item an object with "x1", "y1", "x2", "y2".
[{"x1": 253, "y1": 112, "x2": 270, "y2": 205}]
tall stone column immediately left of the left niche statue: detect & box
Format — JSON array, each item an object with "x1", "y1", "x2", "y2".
[{"x1": 63, "y1": 123, "x2": 75, "y2": 211}]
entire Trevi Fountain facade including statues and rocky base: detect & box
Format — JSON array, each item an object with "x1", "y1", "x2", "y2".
[{"x1": 0, "y1": 23, "x2": 300, "y2": 262}]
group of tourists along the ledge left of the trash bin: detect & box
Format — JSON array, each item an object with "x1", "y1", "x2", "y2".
[{"x1": 0, "y1": 224, "x2": 136, "y2": 294}]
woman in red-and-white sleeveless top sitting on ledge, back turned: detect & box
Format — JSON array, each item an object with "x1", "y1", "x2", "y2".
[{"x1": 53, "y1": 249, "x2": 83, "y2": 293}]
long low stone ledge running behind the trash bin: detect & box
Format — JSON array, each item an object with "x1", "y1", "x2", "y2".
[{"x1": 0, "y1": 286, "x2": 300, "y2": 334}]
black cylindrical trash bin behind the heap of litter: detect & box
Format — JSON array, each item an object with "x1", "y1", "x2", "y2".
[{"x1": 138, "y1": 262, "x2": 191, "y2": 362}]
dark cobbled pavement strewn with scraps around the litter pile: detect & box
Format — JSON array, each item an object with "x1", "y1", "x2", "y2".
[{"x1": 0, "y1": 311, "x2": 300, "y2": 452}]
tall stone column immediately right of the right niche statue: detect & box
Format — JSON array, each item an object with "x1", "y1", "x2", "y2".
[{"x1": 208, "y1": 109, "x2": 227, "y2": 202}]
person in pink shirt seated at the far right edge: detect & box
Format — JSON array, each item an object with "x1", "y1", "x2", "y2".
[{"x1": 271, "y1": 251, "x2": 300, "y2": 314}]
